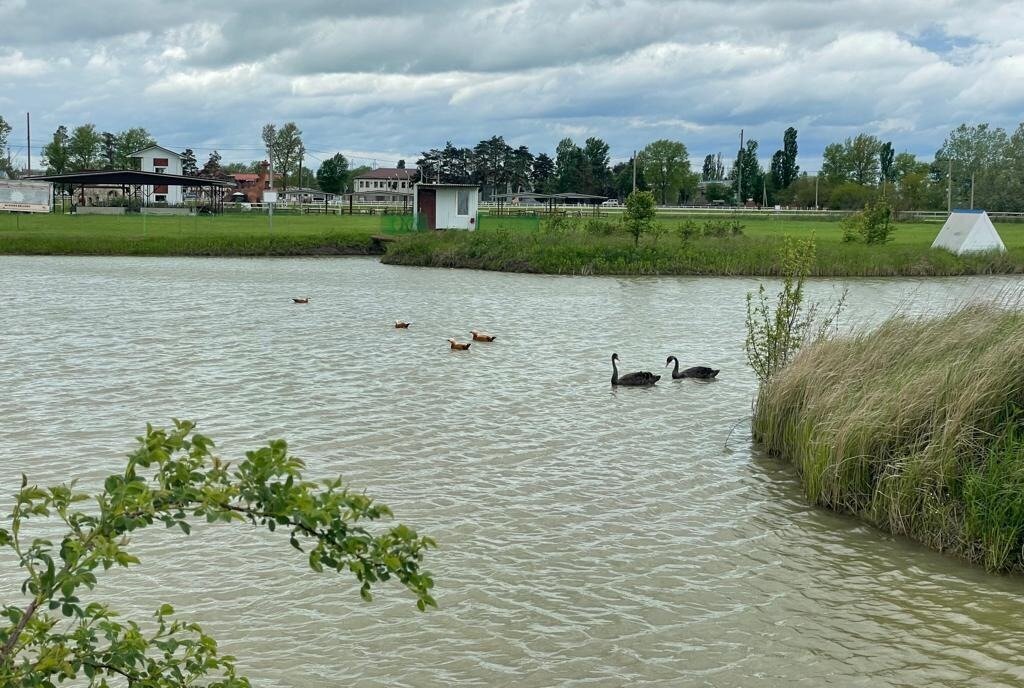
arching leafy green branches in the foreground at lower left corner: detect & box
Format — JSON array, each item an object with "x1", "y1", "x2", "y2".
[{"x1": 0, "y1": 421, "x2": 437, "y2": 688}]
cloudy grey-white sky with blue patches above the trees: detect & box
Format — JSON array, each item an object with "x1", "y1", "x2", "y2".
[{"x1": 0, "y1": 0, "x2": 1024, "y2": 169}]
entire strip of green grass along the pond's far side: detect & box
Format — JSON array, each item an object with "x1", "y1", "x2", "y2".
[{"x1": 6, "y1": 214, "x2": 1024, "y2": 276}]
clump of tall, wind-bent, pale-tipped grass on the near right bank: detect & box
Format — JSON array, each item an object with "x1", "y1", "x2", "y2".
[{"x1": 754, "y1": 306, "x2": 1024, "y2": 570}]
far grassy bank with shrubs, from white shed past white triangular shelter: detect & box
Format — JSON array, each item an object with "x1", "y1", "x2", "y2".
[{"x1": 382, "y1": 220, "x2": 1024, "y2": 276}]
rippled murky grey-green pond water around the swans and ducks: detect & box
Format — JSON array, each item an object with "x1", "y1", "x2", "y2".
[{"x1": 0, "y1": 257, "x2": 1024, "y2": 687}]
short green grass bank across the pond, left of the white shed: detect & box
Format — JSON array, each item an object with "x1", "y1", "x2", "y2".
[{"x1": 0, "y1": 214, "x2": 381, "y2": 256}]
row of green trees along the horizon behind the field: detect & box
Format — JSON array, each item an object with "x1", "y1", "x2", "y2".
[{"x1": 8, "y1": 112, "x2": 1024, "y2": 211}]
